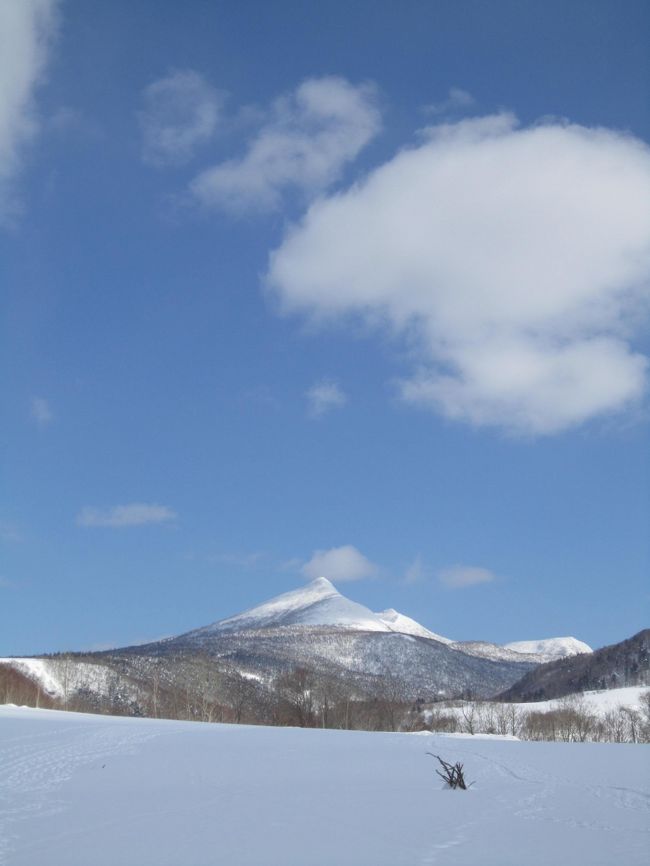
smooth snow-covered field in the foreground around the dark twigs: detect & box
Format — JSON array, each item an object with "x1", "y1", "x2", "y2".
[{"x1": 0, "y1": 706, "x2": 650, "y2": 866}]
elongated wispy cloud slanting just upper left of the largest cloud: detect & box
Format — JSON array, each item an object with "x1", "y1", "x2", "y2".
[{"x1": 191, "y1": 77, "x2": 381, "y2": 213}]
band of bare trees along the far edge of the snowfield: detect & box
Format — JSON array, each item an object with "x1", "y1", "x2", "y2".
[{"x1": 0, "y1": 654, "x2": 650, "y2": 743}]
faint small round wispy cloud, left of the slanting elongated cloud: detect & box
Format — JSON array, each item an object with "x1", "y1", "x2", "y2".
[{"x1": 138, "y1": 69, "x2": 224, "y2": 166}]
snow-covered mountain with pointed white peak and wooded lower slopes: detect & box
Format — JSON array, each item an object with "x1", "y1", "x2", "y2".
[{"x1": 0, "y1": 577, "x2": 588, "y2": 713}]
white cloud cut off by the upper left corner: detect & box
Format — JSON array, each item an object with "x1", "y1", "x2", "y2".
[{"x1": 0, "y1": 0, "x2": 57, "y2": 221}]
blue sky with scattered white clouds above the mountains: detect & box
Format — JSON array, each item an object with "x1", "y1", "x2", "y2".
[{"x1": 0, "y1": 0, "x2": 650, "y2": 655}]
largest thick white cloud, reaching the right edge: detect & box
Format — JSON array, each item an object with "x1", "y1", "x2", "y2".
[{"x1": 268, "y1": 114, "x2": 650, "y2": 434}]
